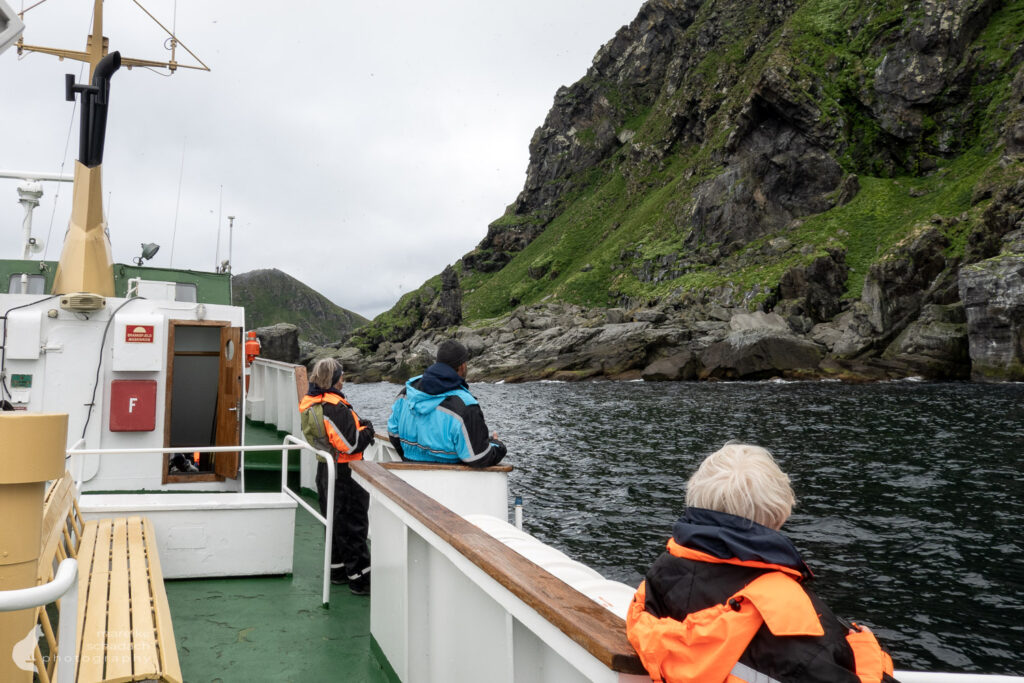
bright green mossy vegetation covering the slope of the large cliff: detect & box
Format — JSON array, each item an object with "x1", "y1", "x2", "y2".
[{"x1": 360, "y1": 0, "x2": 1024, "y2": 346}]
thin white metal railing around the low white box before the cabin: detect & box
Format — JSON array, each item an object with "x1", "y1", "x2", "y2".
[{"x1": 66, "y1": 434, "x2": 335, "y2": 605}]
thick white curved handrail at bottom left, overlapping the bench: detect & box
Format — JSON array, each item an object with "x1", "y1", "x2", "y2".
[{"x1": 0, "y1": 557, "x2": 78, "y2": 683}]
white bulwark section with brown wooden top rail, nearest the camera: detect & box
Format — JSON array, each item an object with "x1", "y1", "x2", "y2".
[{"x1": 352, "y1": 461, "x2": 650, "y2": 683}]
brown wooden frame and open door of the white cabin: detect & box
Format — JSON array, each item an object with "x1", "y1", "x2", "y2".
[{"x1": 162, "y1": 319, "x2": 242, "y2": 483}]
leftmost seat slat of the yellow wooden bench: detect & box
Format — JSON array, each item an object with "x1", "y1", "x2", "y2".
[{"x1": 78, "y1": 519, "x2": 111, "y2": 682}]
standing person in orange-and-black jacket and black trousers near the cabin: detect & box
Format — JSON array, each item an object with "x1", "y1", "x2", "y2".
[{"x1": 299, "y1": 357, "x2": 374, "y2": 595}]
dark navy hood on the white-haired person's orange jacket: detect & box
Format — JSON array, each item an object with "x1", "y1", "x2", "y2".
[{"x1": 672, "y1": 508, "x2": 813, "y2": 579}]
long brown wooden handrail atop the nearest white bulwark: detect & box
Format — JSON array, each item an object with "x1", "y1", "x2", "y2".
[{"x1": 350, "y1": 461, "x2": 645, "y2": 674}]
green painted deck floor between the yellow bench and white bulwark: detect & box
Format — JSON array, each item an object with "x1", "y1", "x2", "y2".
[{"x1": 166, "y1": 501, "x2": 392, "y2": 683}]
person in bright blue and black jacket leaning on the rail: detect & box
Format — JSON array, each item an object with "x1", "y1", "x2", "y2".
[{"x1": 387, "y1": 339, "x2": 507, "y2": 467}]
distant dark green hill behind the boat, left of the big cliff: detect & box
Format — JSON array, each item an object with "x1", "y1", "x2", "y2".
[{"x1": 231, "y1": 268, "x2": 368, "y2": 344}]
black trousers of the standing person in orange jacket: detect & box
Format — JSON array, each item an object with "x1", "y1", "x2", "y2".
[{"x1": 316, "y1": 462, "x2": 370, "y2": 580}]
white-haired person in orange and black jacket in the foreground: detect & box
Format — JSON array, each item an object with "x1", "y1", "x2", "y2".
[{"x1": 626, "y1": 441, "x2": 895, "y2": 683}]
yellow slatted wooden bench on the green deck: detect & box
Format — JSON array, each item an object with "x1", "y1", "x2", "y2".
[{"x1": 37, "y1": 473, "x2": 181, "y2": 683}]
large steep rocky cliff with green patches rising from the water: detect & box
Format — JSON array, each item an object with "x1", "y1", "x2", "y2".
[{"x1": 349, "y1": 0, "x2": 1024, "y2": 379}]
